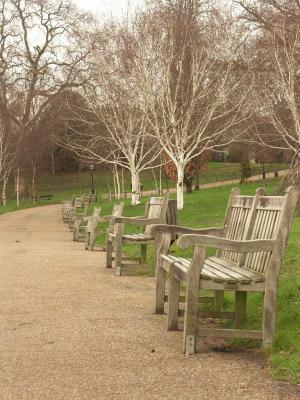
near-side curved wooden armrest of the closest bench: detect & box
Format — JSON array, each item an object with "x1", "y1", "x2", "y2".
[{"x1": 177, "y1": 235, "x2": 275, "y2": 253}]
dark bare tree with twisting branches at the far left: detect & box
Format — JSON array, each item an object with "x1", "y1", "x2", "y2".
[{"x1": 0, "y1": 0, "x2": 93, "y2": 205}]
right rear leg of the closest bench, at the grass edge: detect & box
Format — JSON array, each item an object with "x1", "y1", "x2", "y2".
[{"x1": 262, "y1": 282, "x2": 277, "y2": 347}]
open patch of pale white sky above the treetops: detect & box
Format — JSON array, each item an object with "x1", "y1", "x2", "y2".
[{"x1": 73, "y1": 0, "x2": 143, "y2": 18}]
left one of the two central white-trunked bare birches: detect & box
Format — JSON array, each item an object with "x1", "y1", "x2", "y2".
[{"x1": 61, "y1": 24, "x2": 160, "y2": 205}]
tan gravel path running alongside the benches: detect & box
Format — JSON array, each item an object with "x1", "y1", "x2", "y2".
[{"x1": 0, "y1": 206, "x2": 300, "y2": 400}]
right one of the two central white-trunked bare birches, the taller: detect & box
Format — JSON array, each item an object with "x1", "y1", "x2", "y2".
[{"x1": 140, "y1": 0, "x2": 251, "y2": 209}]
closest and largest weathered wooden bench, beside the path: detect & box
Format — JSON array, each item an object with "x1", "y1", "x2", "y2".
[{"x1": 152, "y1": 187, "x2": 299, "y2": 354}]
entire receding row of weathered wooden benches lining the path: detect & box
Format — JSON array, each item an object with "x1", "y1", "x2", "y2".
[{"x1": 60, "y1": 187, "x2": 299, "y2": 354}]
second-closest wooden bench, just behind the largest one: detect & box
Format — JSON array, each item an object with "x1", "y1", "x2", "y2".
[{"x1": 106, "y1": 197, "x2": 175, "y2": 275}]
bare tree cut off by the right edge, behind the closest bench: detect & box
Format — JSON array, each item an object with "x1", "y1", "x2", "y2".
[{"x1": 239, "y1": 0, "x2": 300, "y2": 191}]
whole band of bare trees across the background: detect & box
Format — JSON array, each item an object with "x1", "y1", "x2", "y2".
[{"x1": 0, "y1": 0, "x2": 300, "y2": 209}]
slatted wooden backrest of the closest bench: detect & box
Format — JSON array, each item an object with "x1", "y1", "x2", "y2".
[{"x1": 218, "y1": 187, "x2": 299, "y2": 274}]
